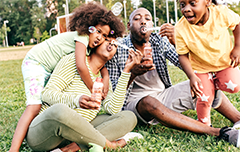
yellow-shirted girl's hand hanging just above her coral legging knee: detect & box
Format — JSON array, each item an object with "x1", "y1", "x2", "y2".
[{"x1": 190, "y1": 75, "x2": 203, "y2": 97}]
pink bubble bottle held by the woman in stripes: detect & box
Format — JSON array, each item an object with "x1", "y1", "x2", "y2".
[{"x1": 92, "y1": 77, "x2": 103, "y2": 108}]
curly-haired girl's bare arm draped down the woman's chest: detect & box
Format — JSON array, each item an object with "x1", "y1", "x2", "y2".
[{"x1": 75, "y1": 41, "x2": 93, "y2": 92}]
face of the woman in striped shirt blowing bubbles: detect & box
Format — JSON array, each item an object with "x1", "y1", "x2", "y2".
[{"x1": 96, "y1": 38, "x2": 117, "y2": 61}]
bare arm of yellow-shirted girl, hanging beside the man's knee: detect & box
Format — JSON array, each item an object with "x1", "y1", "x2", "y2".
[{"x1": 179, "y1": 54, "x2": 202, "y2": 96}]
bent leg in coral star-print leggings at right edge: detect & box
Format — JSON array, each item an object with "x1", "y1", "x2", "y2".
[{"x1": 214, "y1": 67, "x2": 240, "y2": 93}]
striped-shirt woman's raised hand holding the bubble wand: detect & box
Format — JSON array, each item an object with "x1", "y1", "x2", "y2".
[{"x1": 123, "y1": 49, "x2": 143, "y2": 73}]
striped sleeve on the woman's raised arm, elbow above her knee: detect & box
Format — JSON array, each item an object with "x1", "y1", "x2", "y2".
[{"x1": 103, "y1": 72, "x2": 131, "y2": 114}]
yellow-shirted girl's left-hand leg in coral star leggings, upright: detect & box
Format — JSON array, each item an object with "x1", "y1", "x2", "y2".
[{"x1": 196, "y1": 73, "x2": 215, "y2": 126}]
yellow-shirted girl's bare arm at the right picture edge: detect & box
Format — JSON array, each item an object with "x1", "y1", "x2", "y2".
[{"x1": 230, "y1": 23, "x2": 240, "y2": 68}]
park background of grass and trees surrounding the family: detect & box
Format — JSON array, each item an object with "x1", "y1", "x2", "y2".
[{"x1": 0, "y1": 0, "x2": 240, "y2": 152}]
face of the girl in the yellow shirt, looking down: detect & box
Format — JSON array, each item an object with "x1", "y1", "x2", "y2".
[{"x1": 179, "y1": 0, "x2": 211, "y2": 26}]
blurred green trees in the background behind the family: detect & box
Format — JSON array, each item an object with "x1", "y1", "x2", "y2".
[{"x1": 0, "y1": 0, "x2": 240, "y2": 45}]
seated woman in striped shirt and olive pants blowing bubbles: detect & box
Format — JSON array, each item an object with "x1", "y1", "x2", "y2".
[{"x1": 26, "y1": 38, "x2": 142, "y2": 151}]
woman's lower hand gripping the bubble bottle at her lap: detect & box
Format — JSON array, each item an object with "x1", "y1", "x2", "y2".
[{"x1": 79, "y1": 95, "x2": 99, "y2": 110}]
